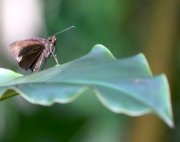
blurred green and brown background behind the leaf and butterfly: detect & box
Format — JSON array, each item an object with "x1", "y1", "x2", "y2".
[{"x1": 0, "y1": 0, "x2": 180, "y2": 142}]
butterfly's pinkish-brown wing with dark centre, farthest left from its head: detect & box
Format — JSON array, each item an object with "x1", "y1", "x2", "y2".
[{"x1": 9, "y1": 38, "x2": 45, "y2": 70}]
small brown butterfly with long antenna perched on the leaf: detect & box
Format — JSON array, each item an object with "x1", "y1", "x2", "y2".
[{"x1": 9, "y1": 26, "x2": 75, "y2": 72}]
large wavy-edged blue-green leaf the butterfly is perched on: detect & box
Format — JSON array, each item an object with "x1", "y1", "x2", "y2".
[{"x1": 0, "y1": 45, "x2": 173, "y2": 127}]
